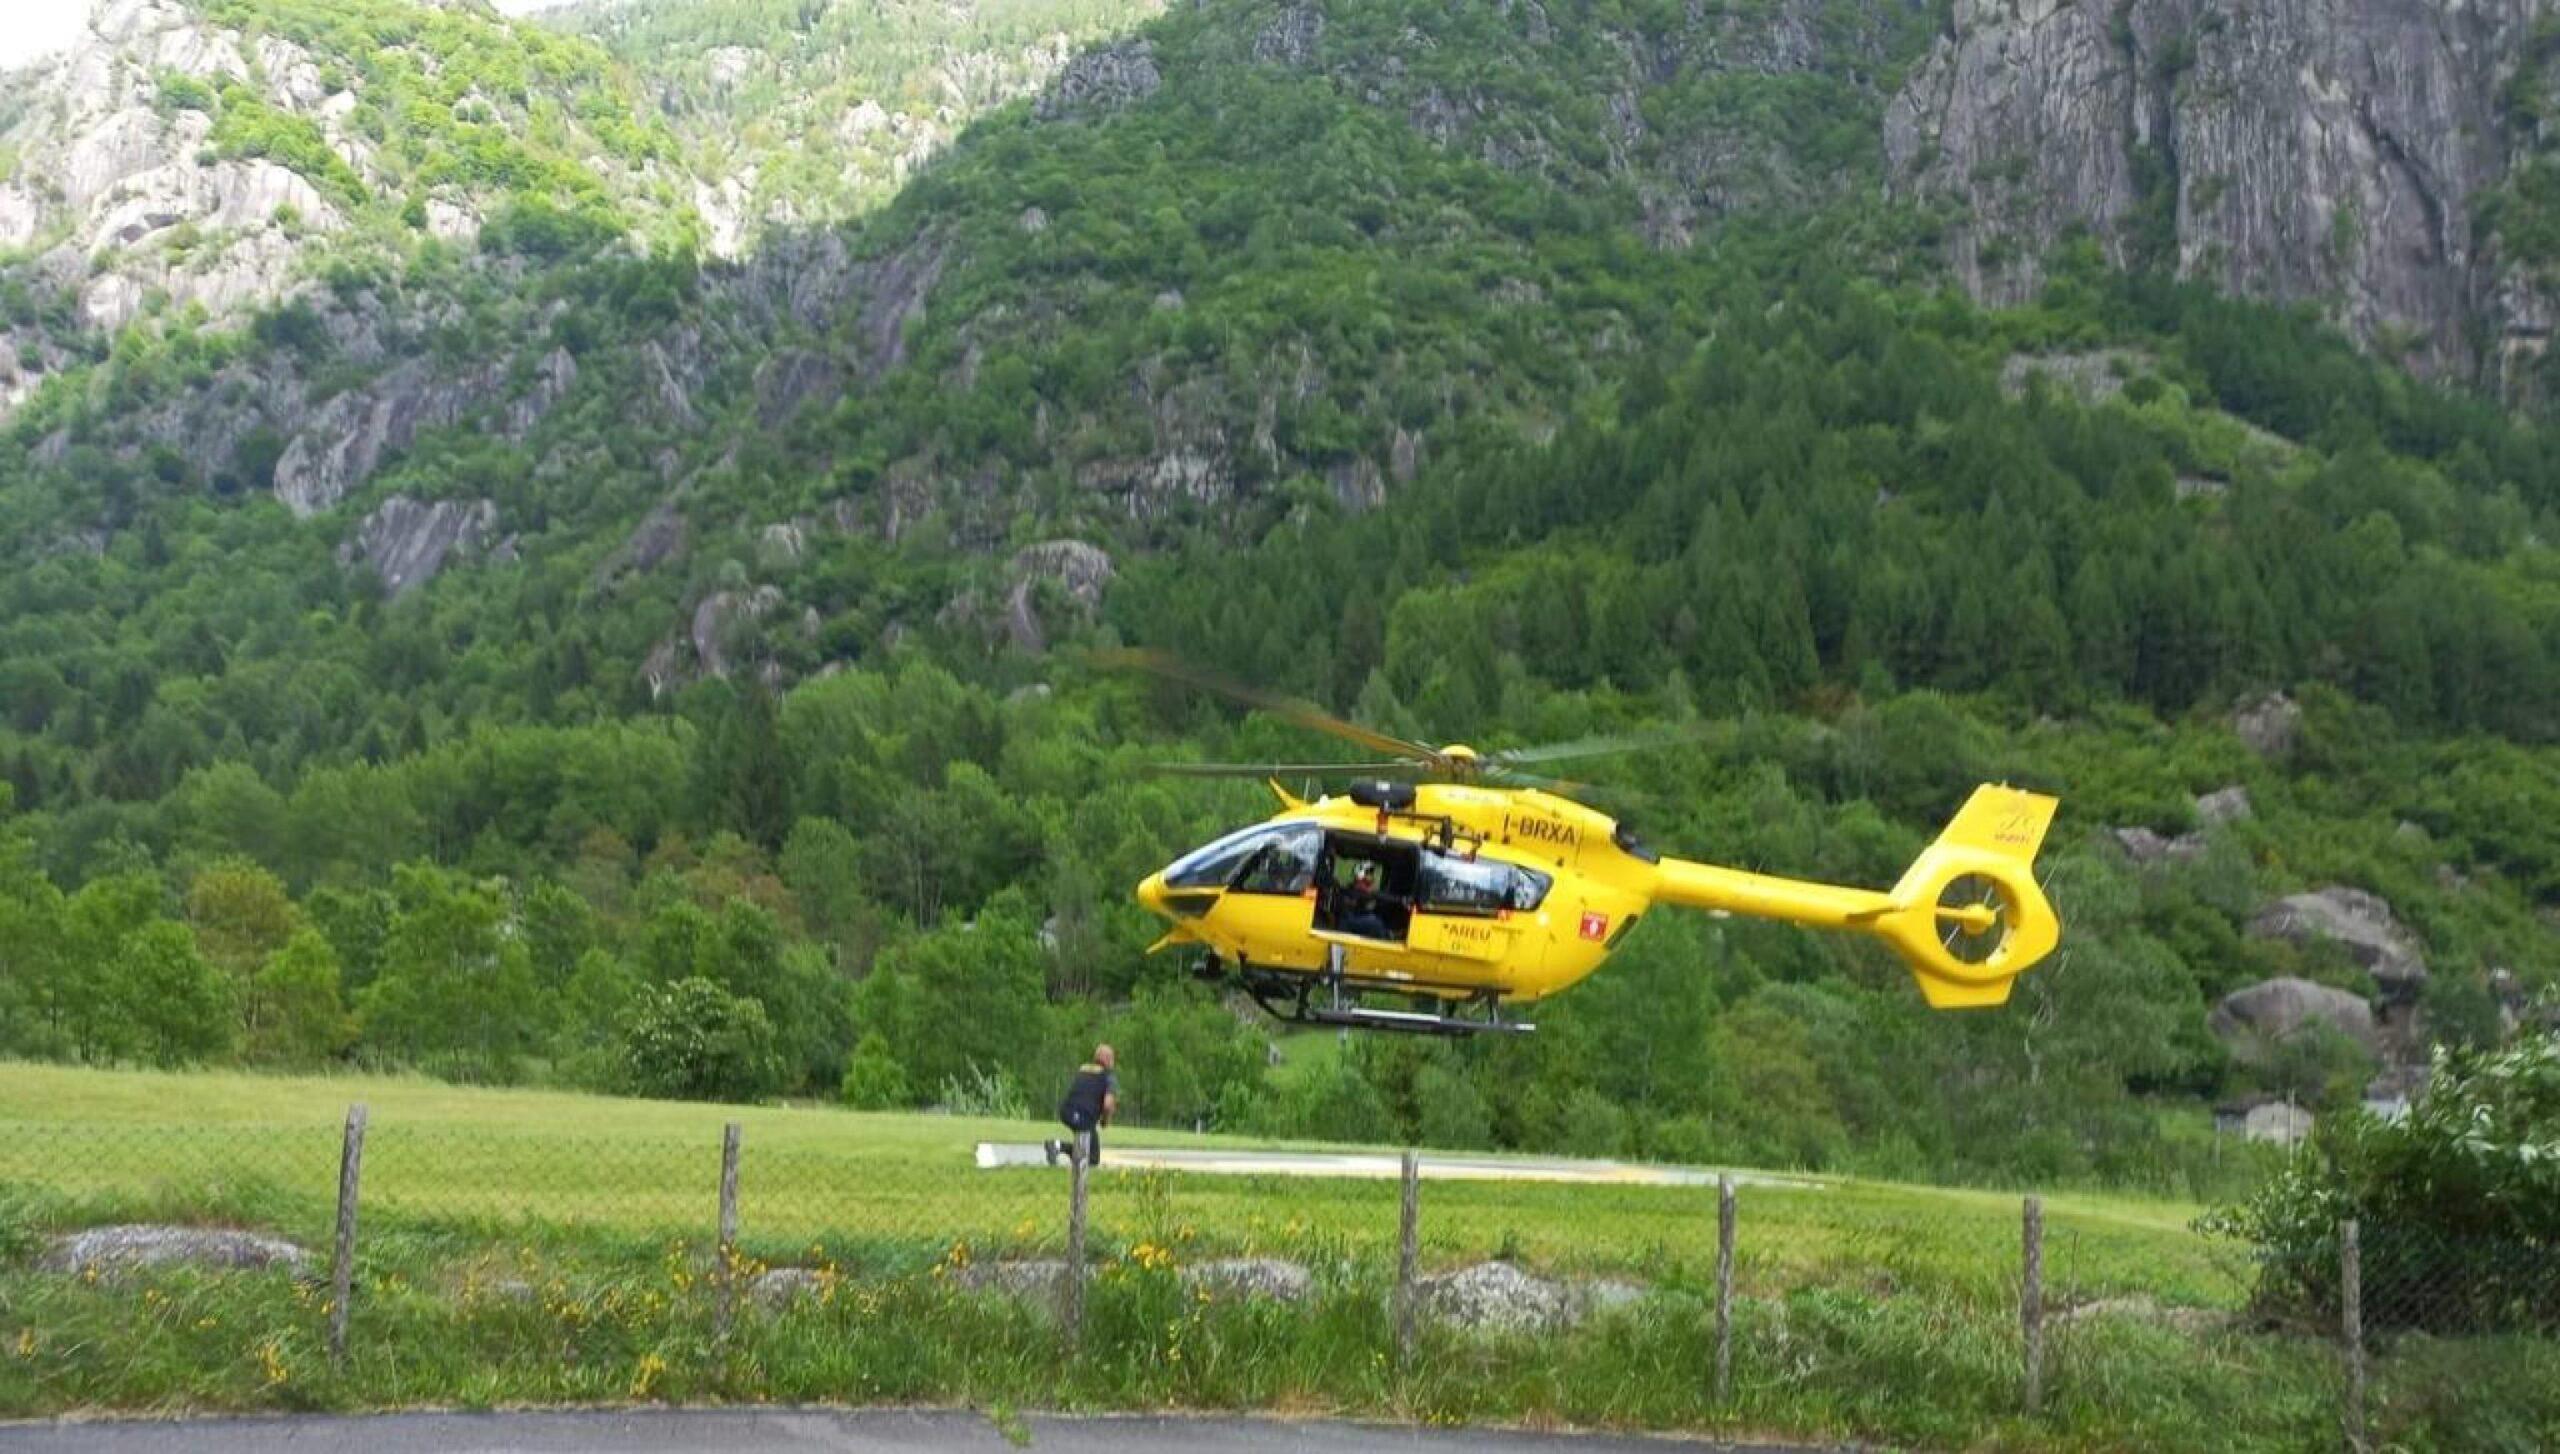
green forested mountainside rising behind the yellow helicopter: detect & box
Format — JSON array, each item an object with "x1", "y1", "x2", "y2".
[{"x1": 0, "y1": 0, "x2": 2560, "y2": 1185}]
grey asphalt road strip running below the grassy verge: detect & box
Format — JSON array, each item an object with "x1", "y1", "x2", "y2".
[{"x1": 0, "y1": 1408, "x2": 1805, "y2": 1454}]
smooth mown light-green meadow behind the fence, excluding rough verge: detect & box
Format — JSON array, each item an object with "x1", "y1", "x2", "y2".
[{"x1": 0, "y1": 1065, "x2": 2243, "y2": 1306}]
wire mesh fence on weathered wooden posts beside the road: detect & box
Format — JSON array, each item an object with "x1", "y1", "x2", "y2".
[{"x1": 0, "y1": 1114, "x2": 2560, "y2": 1446}]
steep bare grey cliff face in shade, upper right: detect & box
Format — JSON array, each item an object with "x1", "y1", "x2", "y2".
[{"x1": 1884, "y1": 0, "x2": 2555, "y2": 381}]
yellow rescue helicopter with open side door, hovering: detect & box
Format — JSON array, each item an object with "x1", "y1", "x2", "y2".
[{"x1": 1106, "y1": 650, "x2": 2061, "y2": 1034}]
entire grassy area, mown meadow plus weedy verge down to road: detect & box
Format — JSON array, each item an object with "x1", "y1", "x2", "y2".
[{"x1": 0, "y1": 1065, "x2": 2560, "y2": 1449}]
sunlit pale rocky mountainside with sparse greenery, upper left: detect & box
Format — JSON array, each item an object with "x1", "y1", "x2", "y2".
[{"x1": 0, "y1": 0, "x2": 689, "y2": 417}]
